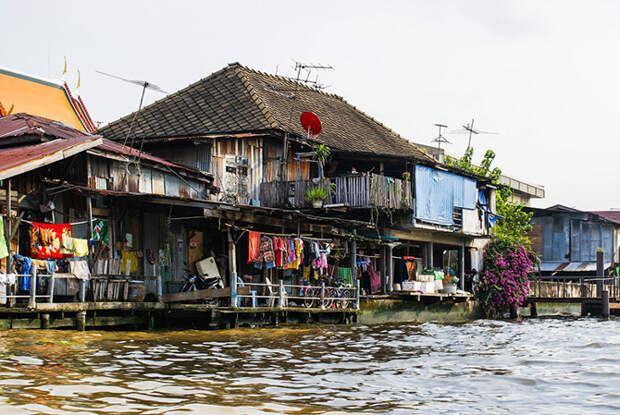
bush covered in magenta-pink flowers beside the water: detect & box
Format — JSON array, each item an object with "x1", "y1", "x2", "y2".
[{"x1": 476, "y1": 240, "x2": 536, "y2": 317}]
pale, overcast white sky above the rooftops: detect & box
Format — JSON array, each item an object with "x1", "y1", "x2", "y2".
[{"x1": 0, "y1": 0, "x2": 620, "y2": 210}]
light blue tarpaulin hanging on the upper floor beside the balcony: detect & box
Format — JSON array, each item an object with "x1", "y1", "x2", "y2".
[{"x1": 415, "y1": 166, "x2": 477, "y2": 225}]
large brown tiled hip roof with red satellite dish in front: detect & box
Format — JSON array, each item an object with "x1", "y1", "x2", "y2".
[{"x1": 100, "y1": 63, "x2": 433, "y2": 162}]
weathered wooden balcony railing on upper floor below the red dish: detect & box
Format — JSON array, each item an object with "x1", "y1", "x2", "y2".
[{"x1": 260, "y1": 174, "x2": 413, "y2": 210}]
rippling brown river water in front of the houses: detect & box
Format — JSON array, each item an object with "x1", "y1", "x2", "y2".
[{"x1": 0, "y1": 318, "x2": 620, "y2": 414}]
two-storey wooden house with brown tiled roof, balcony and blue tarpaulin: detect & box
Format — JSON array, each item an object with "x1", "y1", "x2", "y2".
[{"x1": 99, "y1": 63, "x2": 494, "y2": 287}]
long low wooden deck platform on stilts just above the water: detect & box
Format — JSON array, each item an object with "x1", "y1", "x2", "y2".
[{"x1": 0, "y1": 302, "x2": 359, "y2": 330}]
